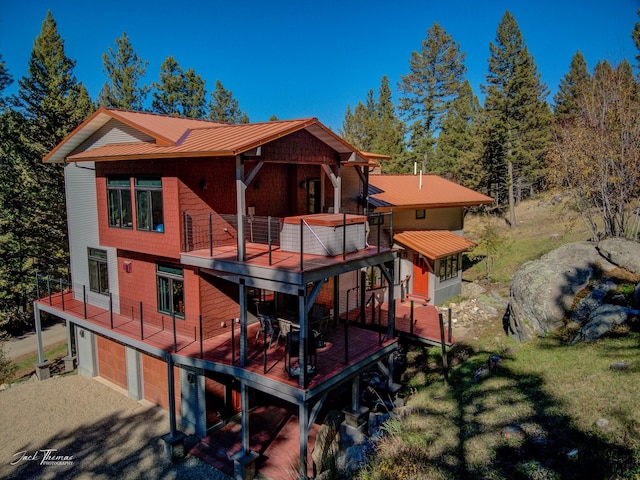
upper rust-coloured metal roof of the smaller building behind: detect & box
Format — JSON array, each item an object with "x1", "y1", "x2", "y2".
[{"x1": 369, "y1": 175, "x2": 493, "y2": 210}]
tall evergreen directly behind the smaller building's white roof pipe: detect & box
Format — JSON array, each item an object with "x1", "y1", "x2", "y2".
[{"x1": 399, "y1": 23, "x2": 466, "y2": 155}]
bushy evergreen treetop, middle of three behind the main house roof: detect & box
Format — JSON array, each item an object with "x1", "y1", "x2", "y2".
[{"x1": 151, "y1": 56, "x2": 206, "y2": 118}]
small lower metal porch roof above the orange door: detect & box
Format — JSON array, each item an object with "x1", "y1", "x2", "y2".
[{"x1": 393, "y1": 230, "x2": 476, "y2": 260}]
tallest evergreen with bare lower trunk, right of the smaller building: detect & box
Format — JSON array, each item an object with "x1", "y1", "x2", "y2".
[{"x1": 483, "y1": 11, "x2": 551, "y2": 225}]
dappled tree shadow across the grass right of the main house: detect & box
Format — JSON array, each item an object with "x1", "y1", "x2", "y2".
[{"x1": 382, "y1": 344, "x2": 640, "y2": 480}]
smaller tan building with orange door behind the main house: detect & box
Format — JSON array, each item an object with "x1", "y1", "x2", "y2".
[{"x1": 368, "y1": 174, "x2": 493, "y2": 305}]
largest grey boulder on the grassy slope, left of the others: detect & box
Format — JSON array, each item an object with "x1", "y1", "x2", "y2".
[{"x1": 505, "y1": 242, "x2": 616, "y2": 341}]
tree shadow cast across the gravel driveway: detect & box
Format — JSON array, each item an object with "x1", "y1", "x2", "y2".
[{"x1": 0, "y1": 402, "x2": 227, "y2": 480}]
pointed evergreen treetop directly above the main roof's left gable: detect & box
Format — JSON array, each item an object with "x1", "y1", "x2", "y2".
[{"x1": 98, "y1": 32, "x2": 150, "y2": 111}]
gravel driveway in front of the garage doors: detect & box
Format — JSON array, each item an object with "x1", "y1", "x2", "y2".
[{"x1": 0, "y1": 375, "x2": 229, "y2": 480}]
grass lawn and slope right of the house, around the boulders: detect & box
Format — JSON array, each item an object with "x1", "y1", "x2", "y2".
[{"x1": 359, "y1": 195, "x2": 640, "y2": 480}]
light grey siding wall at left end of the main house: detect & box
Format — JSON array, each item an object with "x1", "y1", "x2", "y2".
[{"x1": 64, "y1": 162, "x2": 118, "y2": 308}]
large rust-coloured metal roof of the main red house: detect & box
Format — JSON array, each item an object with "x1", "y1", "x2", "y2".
[{"x1": 44, "y1": 108, "x2": 367, "y2": 165}]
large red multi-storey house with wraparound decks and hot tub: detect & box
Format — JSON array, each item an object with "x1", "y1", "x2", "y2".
[{"x1": 34, "y1": 108, "x2": 404, "y2": 479}]
